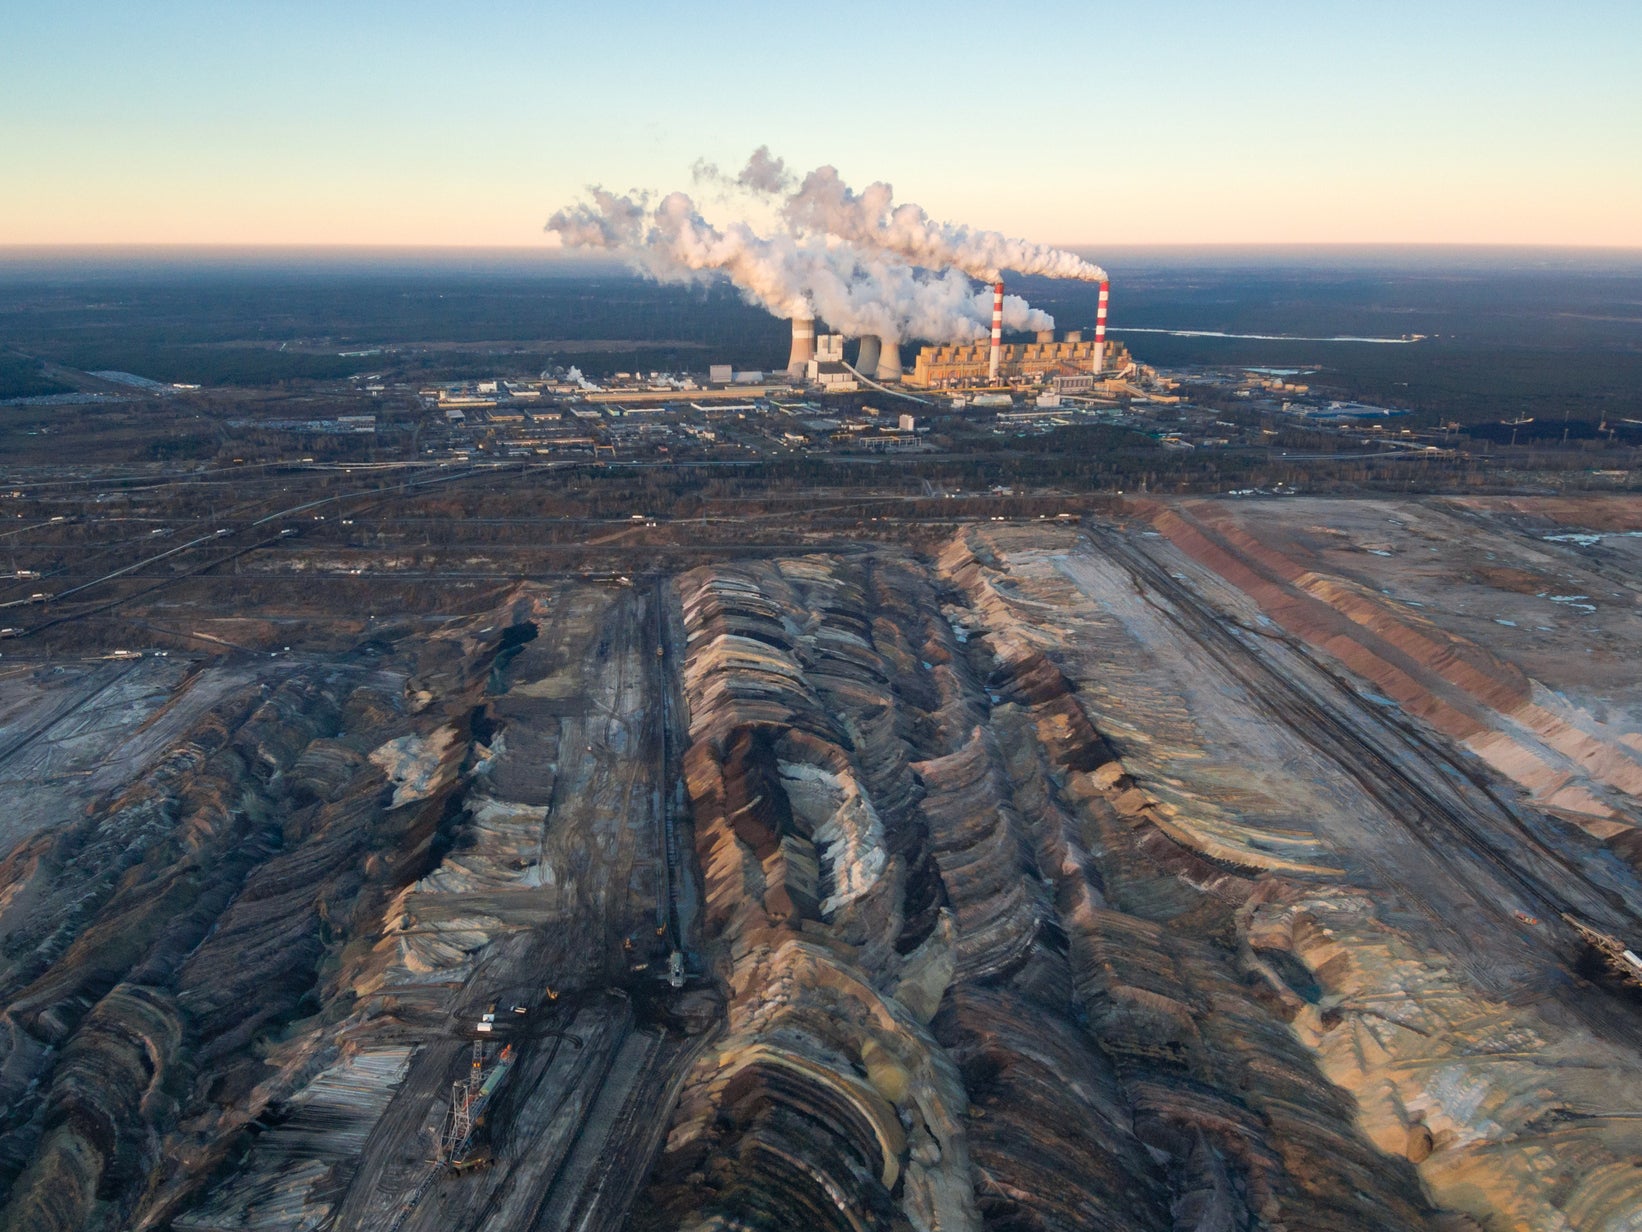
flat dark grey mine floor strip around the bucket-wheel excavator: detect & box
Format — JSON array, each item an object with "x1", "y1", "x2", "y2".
[{"x1": 323, "y1": 580, "x2": 711, "y2": 1232}]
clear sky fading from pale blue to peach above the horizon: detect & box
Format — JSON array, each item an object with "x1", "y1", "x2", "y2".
[{"x1": 0, "y1": 0, "x2": 1642, "y2": 250}]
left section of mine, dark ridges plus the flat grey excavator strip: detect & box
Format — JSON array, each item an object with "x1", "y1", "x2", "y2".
[{"x1": 0, "y1": 585, "x2": 699, "y2": 1229}]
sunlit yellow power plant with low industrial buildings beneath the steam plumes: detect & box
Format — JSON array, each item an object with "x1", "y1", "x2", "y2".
[{"x1": 387, "y1": 272, "x2": 1195, "y2": 460}]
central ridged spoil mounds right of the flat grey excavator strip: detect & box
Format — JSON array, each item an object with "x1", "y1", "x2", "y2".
[{"x1": 623, "y1": 547, "x2": 1464, "y2": 1229}]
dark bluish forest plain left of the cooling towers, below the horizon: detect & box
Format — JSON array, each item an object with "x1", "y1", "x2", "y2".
[{"x1": 0, "y1": 271, "x2": 788, "y2": 386}]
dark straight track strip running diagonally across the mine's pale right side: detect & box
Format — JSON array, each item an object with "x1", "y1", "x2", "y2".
[{"x1": 1082, "y1": 519, "x2": 1642, "y2": 1048}]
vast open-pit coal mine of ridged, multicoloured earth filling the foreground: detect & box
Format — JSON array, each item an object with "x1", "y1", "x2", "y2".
[{"x1": 0, "y1": 496, "x2": 1642, "y2": 1232}]
